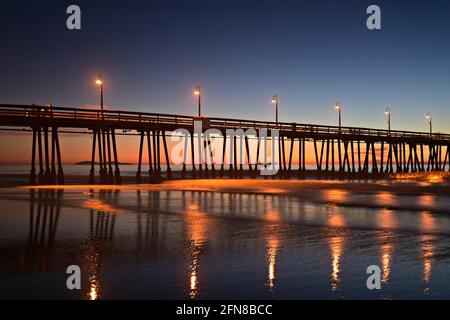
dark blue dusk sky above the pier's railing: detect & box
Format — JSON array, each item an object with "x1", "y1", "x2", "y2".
[{"x1": 0, "y1": 0, "x2": 450, "y2": 132}]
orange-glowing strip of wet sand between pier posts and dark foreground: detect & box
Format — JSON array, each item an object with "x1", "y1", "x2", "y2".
[{"x1": 12, "y1": 179, "x2": 450, "y2": 214}]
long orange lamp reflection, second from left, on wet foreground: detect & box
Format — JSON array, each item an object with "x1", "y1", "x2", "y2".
[{"x1": 185, "y1": 203, "x2": 211, "y2": 299}]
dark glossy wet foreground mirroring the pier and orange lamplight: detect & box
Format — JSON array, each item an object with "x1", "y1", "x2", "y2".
[{"x1": 0, "y1": 189, "x2": 450, "y2": 300}]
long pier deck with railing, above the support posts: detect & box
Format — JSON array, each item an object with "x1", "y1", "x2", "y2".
[{"x1": 0, "y1": 104, "x2": 450, "y2": 142}]
